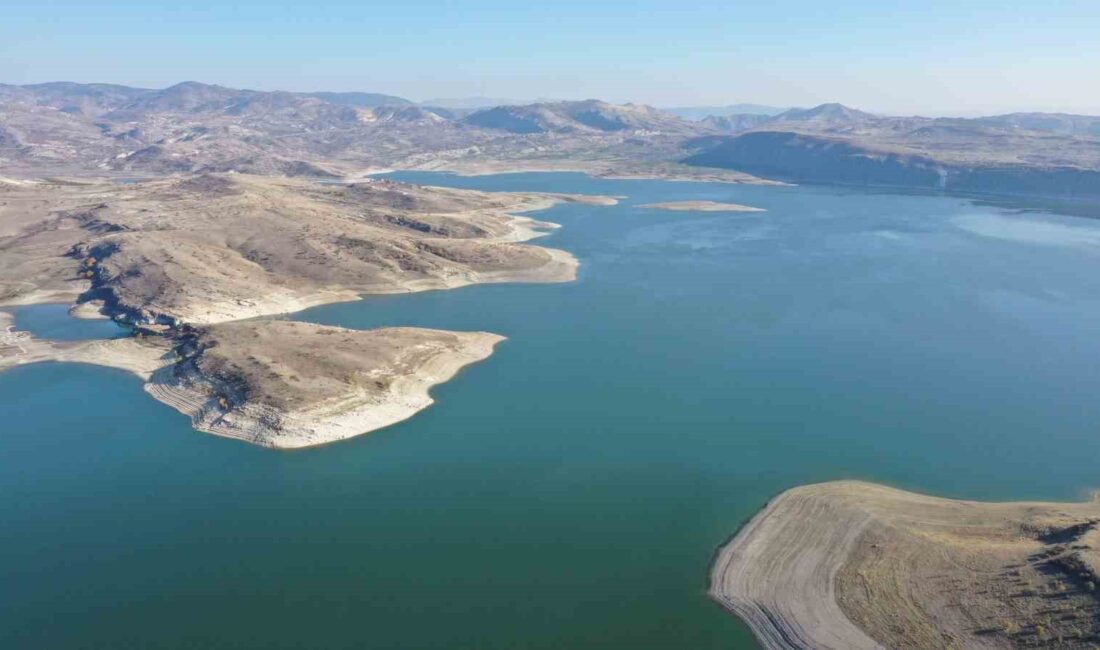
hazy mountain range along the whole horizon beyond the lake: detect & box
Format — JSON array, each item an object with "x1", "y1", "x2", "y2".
[{"x1": 0, "y1": 81, "x2": 1100, "y2": 198}]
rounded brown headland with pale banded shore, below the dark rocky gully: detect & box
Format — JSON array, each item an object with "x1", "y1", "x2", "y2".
[{"x1": 146, "y1": 321, "x2": 504, "y2": 448}]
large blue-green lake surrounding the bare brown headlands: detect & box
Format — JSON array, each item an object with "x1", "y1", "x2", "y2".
[{"x1": 0, "y1": 174, "x2": 1100, "y2": 649}]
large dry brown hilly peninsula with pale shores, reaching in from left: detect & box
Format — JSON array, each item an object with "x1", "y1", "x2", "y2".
[{"x1": 0, "y1": 174, "x2": 615, "y2": 449}]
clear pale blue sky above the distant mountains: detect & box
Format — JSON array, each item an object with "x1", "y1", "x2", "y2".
[{"x1": 0, "y1": 0, "x2": 1100, "y2": 115}]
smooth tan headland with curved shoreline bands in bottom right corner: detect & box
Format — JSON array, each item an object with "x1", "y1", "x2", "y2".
[{"x1": 710, "y1": 482, "x2": 1100, "y2": 649}]
